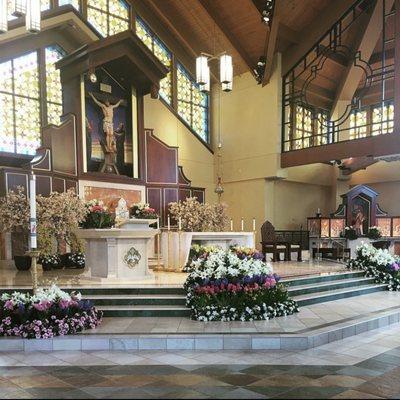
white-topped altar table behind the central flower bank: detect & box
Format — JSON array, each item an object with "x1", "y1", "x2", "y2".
[{"x1": 161, "y1": 231, "x2": 255, "y2": 271}]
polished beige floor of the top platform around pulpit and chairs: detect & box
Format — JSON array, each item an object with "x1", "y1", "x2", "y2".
[{"x1": 0, "y1": 261, "x2": 345, "y2": 288}]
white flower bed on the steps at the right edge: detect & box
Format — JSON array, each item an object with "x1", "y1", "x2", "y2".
[{"x1": 347, "y1": 243, "x2": 400, "y2": 291}]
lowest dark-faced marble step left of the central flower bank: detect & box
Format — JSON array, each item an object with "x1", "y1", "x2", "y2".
[{"x1": 99, "y1": 305, "x2": 190, "y2": 317}]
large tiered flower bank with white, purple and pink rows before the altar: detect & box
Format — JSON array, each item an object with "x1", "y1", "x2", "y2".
[{"x1": 184, "y1": 247, "x2": 298, "y2": 321}]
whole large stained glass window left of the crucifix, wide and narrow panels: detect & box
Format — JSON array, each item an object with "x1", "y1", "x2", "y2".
[{"x1": 0, "y1": 46, "x2": 64, "y2": 155}]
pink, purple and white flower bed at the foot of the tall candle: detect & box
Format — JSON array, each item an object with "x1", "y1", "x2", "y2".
[{"x1": 0, "y1": 285, "x2": 103, "y2": 339}]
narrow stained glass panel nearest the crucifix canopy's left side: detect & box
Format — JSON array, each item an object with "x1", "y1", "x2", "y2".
[{"x1": 45, "y1": 46, "x2": 64, "y2": 125}]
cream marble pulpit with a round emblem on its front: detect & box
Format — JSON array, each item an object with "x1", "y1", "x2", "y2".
[{"x1": 77, "y1": 228, "x2": 159, "y2": 281}]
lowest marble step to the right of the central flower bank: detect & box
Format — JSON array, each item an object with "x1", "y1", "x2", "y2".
[{"x1": 292, "y1": 284, "x2": 387, "y2": 307}]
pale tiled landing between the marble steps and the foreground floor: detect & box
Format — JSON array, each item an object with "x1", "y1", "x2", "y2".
[{"x1": 85, "y1": 291, "x2": 400, "y2": 335}]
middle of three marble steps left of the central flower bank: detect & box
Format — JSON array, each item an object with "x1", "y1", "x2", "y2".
[{"x1": 84, "y1": 294, "x2": 186, "y2": 308}]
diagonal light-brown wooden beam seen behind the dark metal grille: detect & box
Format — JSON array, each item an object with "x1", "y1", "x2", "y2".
[{"x1": 331, "y1": 0, "x2": 394, "y2": 118}]
